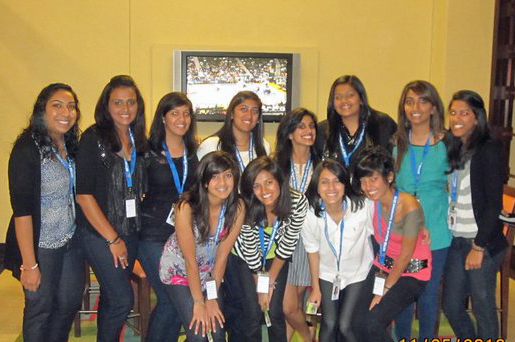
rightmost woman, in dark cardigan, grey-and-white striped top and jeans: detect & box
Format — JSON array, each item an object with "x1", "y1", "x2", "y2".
[{"x1": 442, "y1": 90, "x2": 506, "y2": 340}]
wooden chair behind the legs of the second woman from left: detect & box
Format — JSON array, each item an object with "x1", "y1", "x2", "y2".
[{"x1": 74, "y1": 260, "x2": 151, "y2": 341}]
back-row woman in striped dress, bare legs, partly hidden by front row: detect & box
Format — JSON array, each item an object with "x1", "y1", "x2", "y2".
[{"x1": 274, "y1": 108, "x2": 320, "y2": 341}]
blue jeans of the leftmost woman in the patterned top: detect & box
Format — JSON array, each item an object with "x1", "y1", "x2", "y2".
[{"x1": 23, "y1": 242, "x2": 84, "y2": 342}]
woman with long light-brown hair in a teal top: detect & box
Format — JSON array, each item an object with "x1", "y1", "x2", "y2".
[{"x1": 394, "y1": 81, "x2": 451, "y2": 339}]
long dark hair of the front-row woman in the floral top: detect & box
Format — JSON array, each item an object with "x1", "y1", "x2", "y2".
[{"x1": 177, "y1": 151, "x2": 240, "y2": 243}]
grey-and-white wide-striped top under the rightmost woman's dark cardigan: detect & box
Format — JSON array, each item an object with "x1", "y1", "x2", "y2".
[{"x1": 449, "y1": 160, "x2": 478, "y2": 238}]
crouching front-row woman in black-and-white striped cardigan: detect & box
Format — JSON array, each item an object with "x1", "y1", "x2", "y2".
[{"x1": 235, "y1": 157, "x2": 308, "y2": 342}]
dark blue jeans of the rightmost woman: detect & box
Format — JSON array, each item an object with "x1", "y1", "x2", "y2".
[{"x1": 442, "y1": 237, "x2": 506, "y2": 340}]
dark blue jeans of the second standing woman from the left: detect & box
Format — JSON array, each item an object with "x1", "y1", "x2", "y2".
[{"x1": 82, "y1": 228, "x2": 138, "y2": 342}]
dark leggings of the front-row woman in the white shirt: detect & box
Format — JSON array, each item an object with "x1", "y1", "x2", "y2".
[{"x1": 319, "y1": 274, "x2": 373, "y2": 342}]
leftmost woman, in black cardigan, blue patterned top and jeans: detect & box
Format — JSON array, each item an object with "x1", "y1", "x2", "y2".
[{"x1": 5, "y1": 83, "x2": 84, "y2": 342}]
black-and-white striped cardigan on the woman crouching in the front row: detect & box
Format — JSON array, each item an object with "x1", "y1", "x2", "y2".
[{"x1": 234, "y1": 189, "x2": 308, "y2": 271}]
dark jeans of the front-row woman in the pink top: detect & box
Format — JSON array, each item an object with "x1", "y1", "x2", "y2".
[{"x1": 365, "y1": 266, "x2": 427, "y2": 342}]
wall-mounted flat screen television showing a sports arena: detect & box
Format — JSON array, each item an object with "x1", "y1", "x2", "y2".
[{"x1": 174, "y1": 51, "x2": 299, "y2": 122}]
